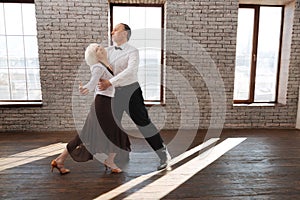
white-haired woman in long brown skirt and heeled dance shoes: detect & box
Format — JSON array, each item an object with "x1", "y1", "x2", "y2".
[{"x1": 51, "y1": 43, "x2": 130, "y2": 175}]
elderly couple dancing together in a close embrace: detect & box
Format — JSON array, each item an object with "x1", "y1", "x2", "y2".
[{"x1": 51, "y1": 23, "x2": 171, "y2": 174}]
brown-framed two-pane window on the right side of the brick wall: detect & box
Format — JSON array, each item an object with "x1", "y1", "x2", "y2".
[{"x1": 234, "y1": 5, "x2": 283, "y2": 103}]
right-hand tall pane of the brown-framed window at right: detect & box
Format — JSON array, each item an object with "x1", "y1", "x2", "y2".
[{"x1": 254, "y1": 7, "x2": 281, "y2": 102}]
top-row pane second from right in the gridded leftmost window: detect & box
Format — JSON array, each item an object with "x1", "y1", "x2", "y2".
[{"x1": 4, "y1": 3, "x2": 23, "y2": 35}]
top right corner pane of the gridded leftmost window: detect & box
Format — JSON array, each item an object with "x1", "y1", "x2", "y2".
[{"x1": 22, "y1": 4, "x2": 37, "y2": 35}]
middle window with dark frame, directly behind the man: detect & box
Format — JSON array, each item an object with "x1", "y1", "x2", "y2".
[{"x1": 111, "y1": 4, "x2": 164, "y2": 104}]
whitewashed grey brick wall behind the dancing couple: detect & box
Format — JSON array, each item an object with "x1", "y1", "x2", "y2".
[{"x1": 0, "y1": 0, "x2": 300, "y2": 132}]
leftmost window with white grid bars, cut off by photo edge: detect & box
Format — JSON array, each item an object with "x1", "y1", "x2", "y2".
[{"x1": 0, "y1": 0, "x2": 42, "y2": 104}]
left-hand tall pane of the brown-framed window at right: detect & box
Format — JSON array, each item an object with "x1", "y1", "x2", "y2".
[{"x1": 234, "y1": 8, "x2": 254, "y2": 100}]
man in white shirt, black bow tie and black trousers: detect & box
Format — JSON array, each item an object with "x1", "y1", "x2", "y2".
[{"x1": 97, "y1": 23, "x2": 171, "y2": 170}]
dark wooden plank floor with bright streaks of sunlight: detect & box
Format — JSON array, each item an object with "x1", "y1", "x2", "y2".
[{"x1": 0, "y1": 129, "x2": 300, "y2": 200}]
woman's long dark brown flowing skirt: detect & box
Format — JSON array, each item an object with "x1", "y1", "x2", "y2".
[{"x1": 67, "y1": 95, "x2": 131, "y2": 162}]
